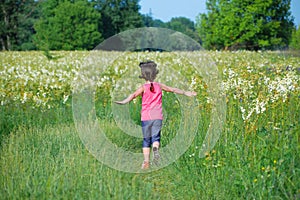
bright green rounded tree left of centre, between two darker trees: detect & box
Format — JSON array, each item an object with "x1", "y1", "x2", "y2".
[{"x1": 35, "y1": 0, "x2": 102, "y2": 50}]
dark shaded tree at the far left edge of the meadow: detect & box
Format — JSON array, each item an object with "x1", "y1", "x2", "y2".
[{"x1": 0, "y1": 0, "x2": 38, "y2": 50}]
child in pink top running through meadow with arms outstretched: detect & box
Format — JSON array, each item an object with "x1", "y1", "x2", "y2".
[{"x1": 115, "y1": 61, "x2": 197, "y2": 169}]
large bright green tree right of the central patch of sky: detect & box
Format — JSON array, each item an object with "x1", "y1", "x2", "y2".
[{"x1": 197, "y1": 0, "x2": 294, "y2": 50}]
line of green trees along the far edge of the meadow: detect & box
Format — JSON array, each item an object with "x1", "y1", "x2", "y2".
[{"x1": 0, "y1": 0, "x2": 299, "y2": 51}]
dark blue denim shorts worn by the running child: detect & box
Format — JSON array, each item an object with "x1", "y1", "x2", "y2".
[{"x1": 142, "y1": 119, "x2": 162, "y2": 147}]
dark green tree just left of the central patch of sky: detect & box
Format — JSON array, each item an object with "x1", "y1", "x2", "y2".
[{"x1": 93, "y1": 0, "x2": 143, "y2": 39}]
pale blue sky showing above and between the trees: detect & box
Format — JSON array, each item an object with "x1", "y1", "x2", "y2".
[{"x1": 140, "y1": 0, "x2": 300, "y2": 27}]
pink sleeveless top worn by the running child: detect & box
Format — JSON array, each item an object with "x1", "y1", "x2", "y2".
[{"x1": 141, "y1": 82, "x2": 163, "y2": 121}]
